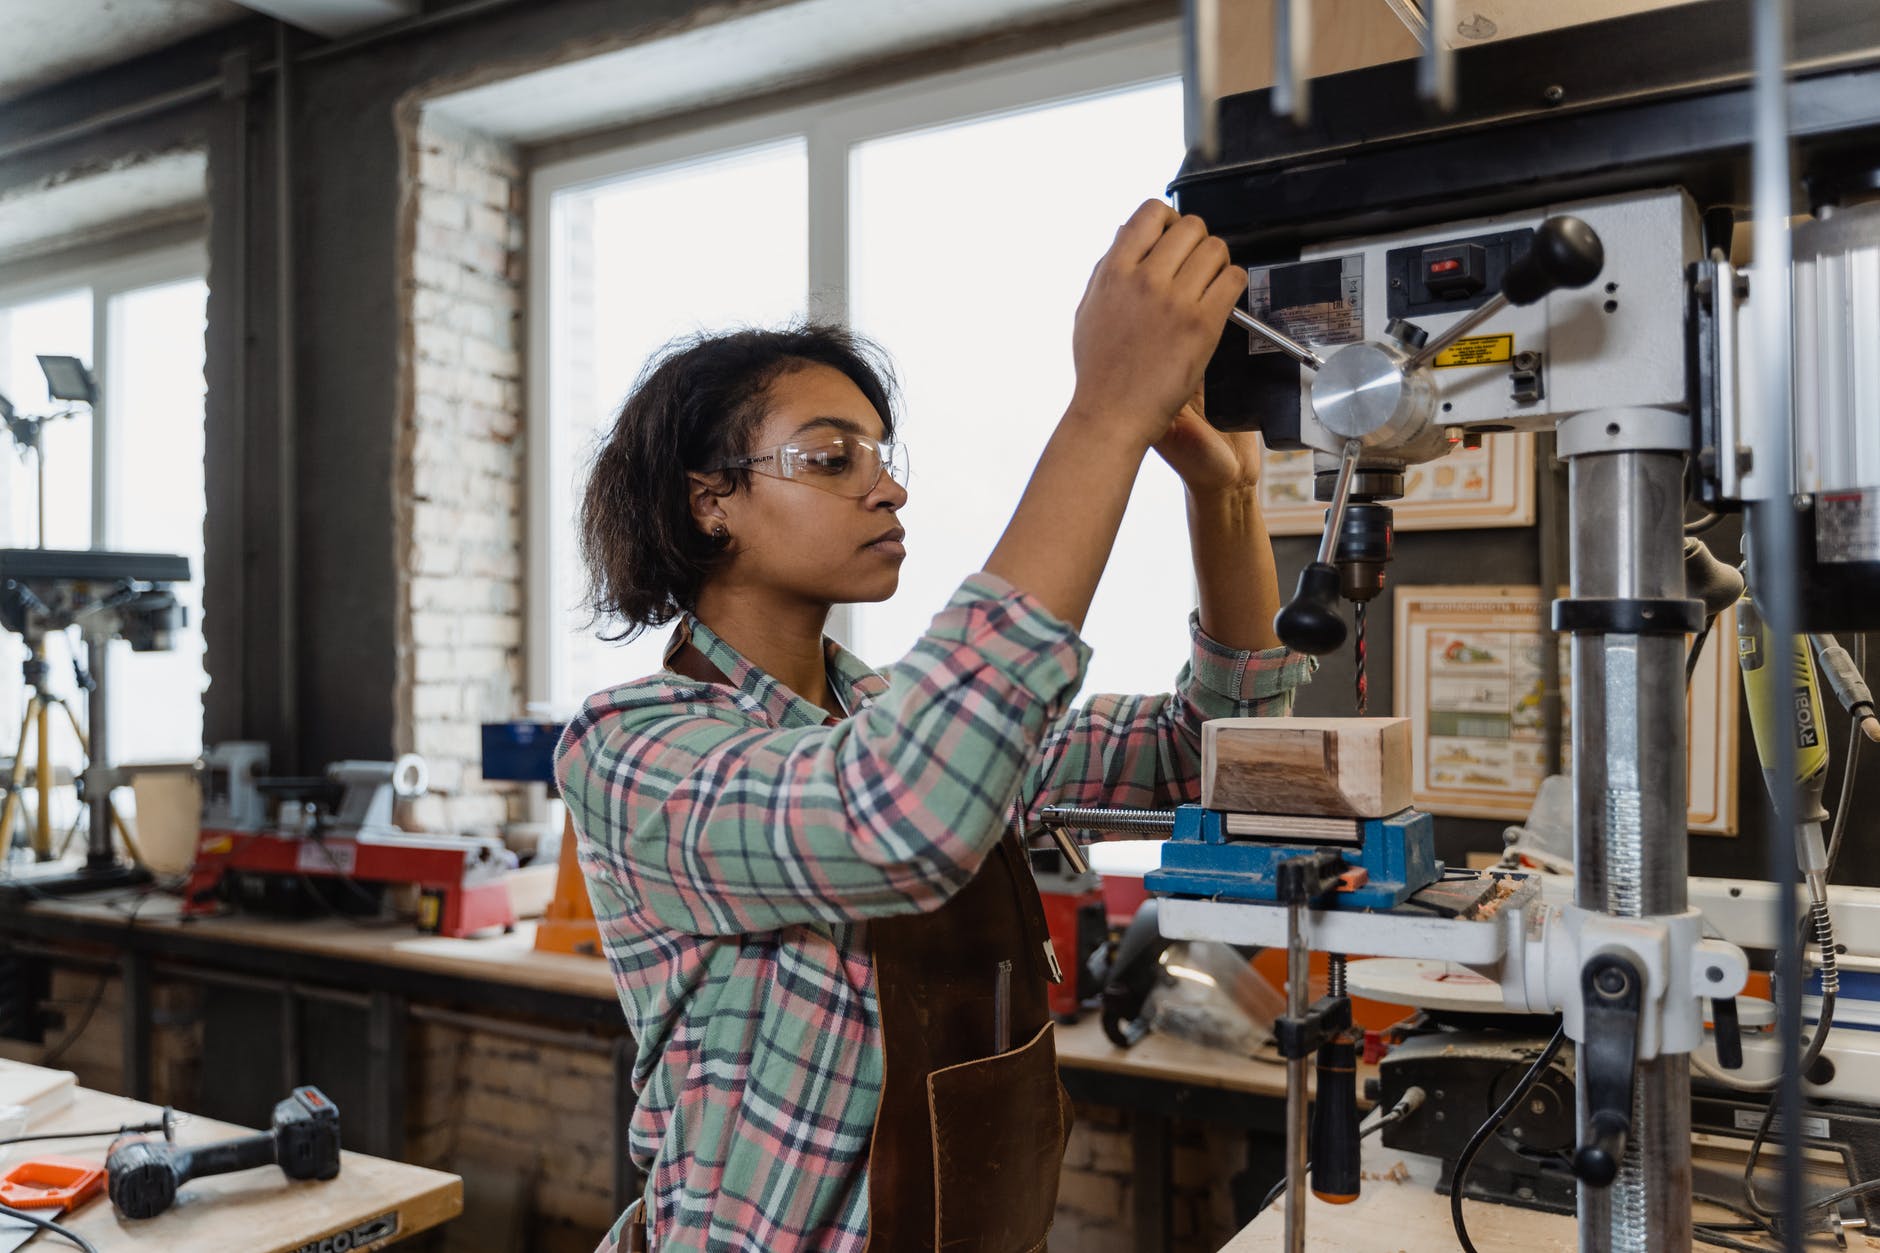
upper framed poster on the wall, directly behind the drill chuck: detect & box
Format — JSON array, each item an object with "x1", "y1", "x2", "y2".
[{"x1": 1260, "y1": 431, "x2": 1534, "y2": 534}]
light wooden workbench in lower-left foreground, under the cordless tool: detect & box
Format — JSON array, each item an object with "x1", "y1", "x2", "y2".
[{"x1": 0, "y1": 1061, "x2": 454, "y2": 1253}]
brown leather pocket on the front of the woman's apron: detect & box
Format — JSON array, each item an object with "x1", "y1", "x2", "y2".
[{"x1": 927, "y1": 1022, "x2": 1070, "y2": 1253}]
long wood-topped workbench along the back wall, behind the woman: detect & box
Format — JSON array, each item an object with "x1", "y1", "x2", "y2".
[{"x1": 0, "y1": 896, "x2": 1286, "y2": 1253}]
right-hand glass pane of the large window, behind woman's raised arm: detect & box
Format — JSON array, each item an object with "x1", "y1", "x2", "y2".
[{"x1": 850, "y1": 83, "x2": 1194, "y2": 692}]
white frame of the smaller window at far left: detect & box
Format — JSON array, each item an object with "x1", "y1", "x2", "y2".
[{"x1": 0, "y1": 239, "x2": 209, "y2": 549}]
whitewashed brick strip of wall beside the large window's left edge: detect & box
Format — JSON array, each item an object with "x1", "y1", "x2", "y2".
[{"x1": 395, "y1": 119, "x2": 526, "y2": 832}]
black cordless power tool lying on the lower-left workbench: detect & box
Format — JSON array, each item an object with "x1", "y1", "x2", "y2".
[{"x1": 105, "y1": 1087, "x2": 340, "y2": 1219}]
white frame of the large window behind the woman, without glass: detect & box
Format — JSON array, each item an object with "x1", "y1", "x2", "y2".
[{"x1": 523, "y1": 23, "x2": 1181, "y2": 713}]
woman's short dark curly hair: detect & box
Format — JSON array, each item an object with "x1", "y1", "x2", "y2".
[{"x1": 581, "y1": 322, "x2": 895, "y2": 640}]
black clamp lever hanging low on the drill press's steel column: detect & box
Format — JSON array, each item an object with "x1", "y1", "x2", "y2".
[{"x1": 1574, "y1": 952, "x2": 1643, "y2": 1187}]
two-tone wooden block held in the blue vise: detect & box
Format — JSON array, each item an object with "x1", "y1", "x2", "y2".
[{"x1": 1201, "y1": 719, "x2": 1410, "y2": 818}]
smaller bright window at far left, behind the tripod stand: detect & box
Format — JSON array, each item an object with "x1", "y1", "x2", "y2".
[{"x1": 0, "y1": 248, "x2": 209, "y2": 801}]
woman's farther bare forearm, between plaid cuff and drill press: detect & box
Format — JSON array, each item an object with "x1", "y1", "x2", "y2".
[{"x1": 1188, "y1": 485, "x2": 1280, "y2": 651}]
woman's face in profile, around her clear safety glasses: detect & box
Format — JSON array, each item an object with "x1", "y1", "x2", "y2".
[{"x1": 696, "y1": 365, "x2": 908, "y2": 604}]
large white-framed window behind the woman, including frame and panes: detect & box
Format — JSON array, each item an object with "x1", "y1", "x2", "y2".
[{"x1": 528, "y1": 32, "x2": 1194, "y2": 713}]
